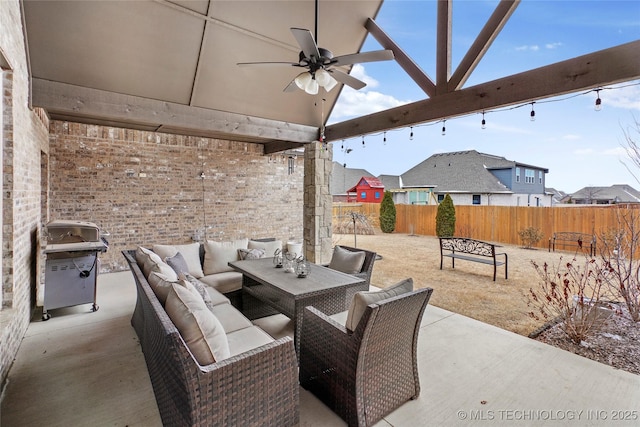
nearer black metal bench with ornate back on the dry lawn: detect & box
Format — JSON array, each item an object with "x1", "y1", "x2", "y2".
[{"x1": 440, "y1": 237, "x2": 508, "y2": 282}]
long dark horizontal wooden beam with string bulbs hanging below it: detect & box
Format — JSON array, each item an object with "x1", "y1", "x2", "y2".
[{"x1": 325, "y1": 40, "x2": 640, "y2": 142}]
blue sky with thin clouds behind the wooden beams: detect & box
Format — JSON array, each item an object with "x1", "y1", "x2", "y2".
[{"x1": 329, "y1": 0, "x2": 640, "y2": 193}]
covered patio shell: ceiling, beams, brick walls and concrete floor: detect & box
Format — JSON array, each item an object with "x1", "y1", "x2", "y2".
[{"x1": 0, "y1": 0, "x2": 640, "y2": 426}]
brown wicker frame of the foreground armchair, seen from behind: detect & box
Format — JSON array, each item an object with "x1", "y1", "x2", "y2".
[{"x1": 300, "y1": 288, "x2": 433, "y2": 426}]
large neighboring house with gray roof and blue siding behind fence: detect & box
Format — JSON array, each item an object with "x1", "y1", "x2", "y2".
[{"x1": 387, "y1": 150, "x2": 552, "y2": 206}]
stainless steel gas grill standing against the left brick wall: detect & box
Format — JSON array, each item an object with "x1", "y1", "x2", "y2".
[{"x1": 38, "y1": 220, "x2": 109, "y2": 320}]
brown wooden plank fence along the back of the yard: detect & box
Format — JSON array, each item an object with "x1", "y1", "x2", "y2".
[{"x1": 333, "y1": 203, "x2": 640, "y2": 248}]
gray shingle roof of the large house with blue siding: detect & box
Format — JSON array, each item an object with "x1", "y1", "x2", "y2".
[{"x1": 402, "y1": 150, "x2": 516, "y2": 193}]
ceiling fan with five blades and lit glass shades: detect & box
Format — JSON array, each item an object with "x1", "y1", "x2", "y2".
[{"x1": 238, "y1": 0, "x2": 394, "y2": 95}]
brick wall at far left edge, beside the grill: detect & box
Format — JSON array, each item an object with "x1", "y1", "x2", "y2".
[{"x1": 0, "y1": 0, "x2": 48, "y2": 393}]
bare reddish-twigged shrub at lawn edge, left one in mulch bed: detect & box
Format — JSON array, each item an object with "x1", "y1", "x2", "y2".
[{"x1": 527, "y1": 257, "x2": 612, "y2": 344}]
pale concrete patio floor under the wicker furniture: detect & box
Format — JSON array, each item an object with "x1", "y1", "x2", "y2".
[{"x1": 0, "y1": 271, "x2": 640, "y2": 427}]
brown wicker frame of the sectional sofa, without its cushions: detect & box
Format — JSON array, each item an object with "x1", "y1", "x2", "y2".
[{"x1": 123, "y1": 251, "x2": 300, "y2": 426}]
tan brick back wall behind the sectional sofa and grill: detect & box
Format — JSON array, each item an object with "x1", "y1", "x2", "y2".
[{"x1": 48, "y1": 121, "x2": 304, "y2": 272}]
